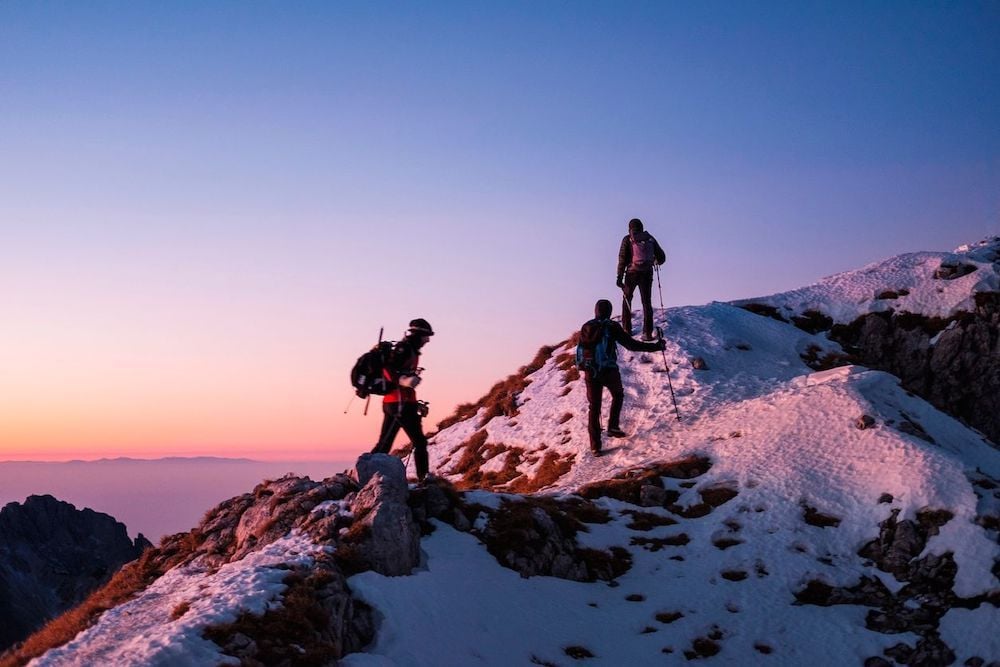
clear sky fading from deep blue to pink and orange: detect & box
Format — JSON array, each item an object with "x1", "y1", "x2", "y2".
[{"x1": 0, "y1": 1, "x2": 1000, "y2": 460}]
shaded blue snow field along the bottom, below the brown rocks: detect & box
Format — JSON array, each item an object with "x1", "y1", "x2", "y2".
[{"x1": 341, "y1": 521, "x2": 914, "y2": 667}]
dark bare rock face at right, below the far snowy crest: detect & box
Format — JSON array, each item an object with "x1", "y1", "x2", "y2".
[{"x1": 830, "y1": 292, "x2": 1000, "y2": 443}]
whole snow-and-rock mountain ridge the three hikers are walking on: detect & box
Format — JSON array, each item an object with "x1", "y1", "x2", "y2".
[{"x1": 3, "y1": 238, "x2": 1000, "y2": 666}]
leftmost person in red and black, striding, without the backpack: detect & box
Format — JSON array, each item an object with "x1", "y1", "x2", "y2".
[{"x1": 372, "y1": 318, "x2": 434, "y2": 482}]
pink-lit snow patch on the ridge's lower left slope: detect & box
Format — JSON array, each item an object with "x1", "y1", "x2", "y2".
[{"x1": 29, "y1": 532, "x2": 323, "y2": 667}]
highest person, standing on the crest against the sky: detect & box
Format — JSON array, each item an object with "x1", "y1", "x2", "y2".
[{"x1": 615, "y1": 218, "x2": 667, "y2": 341}]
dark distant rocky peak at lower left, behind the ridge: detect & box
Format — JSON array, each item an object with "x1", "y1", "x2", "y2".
[{"x1": 0, "y1": 496, "x2": 152, "y2": 650}]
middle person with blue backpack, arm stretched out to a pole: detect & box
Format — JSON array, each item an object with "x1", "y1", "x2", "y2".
[{"x1": 576, "y1": 299, "x2": 667, "y2": 456}]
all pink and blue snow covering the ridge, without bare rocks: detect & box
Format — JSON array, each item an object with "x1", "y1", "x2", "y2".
[{"x1": 35, "y1": 239, "x2": 1000, "y2": 667}]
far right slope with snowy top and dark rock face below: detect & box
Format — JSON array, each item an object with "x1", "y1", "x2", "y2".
[{"x1": 739, "y1": 237, "x2": 1000, "y2": 442}]
